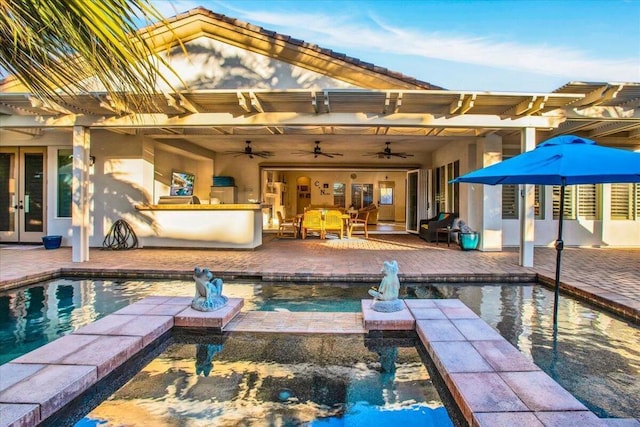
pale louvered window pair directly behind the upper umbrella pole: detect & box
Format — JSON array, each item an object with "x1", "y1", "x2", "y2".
[{"x1": 553, "y1": 184, "x2": 601, "y2": 220}]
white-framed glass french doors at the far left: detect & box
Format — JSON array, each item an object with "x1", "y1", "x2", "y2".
[{"x1": 0, "y1": 147, "x2": 47, "y2": 243}]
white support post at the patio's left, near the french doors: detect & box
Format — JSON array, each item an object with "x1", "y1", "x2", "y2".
[{"x1": 71, "y1": 126, "x2": 91, "y2": 262}]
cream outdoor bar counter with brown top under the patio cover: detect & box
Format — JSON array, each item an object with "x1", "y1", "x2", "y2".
[{"x1": 136, "y1": 203, "x2": 264, "y2": 249}]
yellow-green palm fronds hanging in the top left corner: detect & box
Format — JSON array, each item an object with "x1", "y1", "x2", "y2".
[{"x1": 0, "y1": 0, "x2": 185, "y2": 107}]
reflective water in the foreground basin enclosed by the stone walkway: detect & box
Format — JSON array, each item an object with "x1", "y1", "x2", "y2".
[{"x1": 76, "y1": 333, "x2": 453, "y2": 427}]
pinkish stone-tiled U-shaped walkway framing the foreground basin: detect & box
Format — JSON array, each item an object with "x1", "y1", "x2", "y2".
[{"x1": 0, "y1": 296, "x2": 637, "y2": 427}]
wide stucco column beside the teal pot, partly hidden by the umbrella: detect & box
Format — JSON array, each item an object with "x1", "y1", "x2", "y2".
[{"x1": 470, "y1": 135, "x2": 502, "y2": 252}]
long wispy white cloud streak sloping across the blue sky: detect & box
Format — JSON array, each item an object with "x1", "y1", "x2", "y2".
[{"x1": 192, "y1": 2, "x2": 640, "y2": 82}]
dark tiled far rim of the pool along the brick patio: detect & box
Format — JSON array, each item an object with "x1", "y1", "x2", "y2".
[{"x1": 0, "y1": 267, "x2": 640, "y2": 325}]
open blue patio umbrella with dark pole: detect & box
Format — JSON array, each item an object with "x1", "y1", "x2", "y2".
[{"x1": 452, "y1": 135, "x2": 640, "y2": 326}]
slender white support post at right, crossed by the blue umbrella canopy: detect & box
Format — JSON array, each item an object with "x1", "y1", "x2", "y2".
[{"x1": 518, "y1": 128, "x2": 542, "y2": 267}]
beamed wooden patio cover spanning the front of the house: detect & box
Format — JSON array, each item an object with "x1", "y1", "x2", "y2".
[{"x1": 0, "y1": 83, "x2": 640, "y2": 164}]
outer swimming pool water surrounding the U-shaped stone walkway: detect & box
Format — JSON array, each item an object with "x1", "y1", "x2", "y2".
[{"x1": 0, "y1": 279, "x2": 640, "y2": 418}]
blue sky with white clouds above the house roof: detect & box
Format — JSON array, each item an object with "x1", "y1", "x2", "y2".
[{"x1": 153, "y1": 0, "x2": 640, "y2": 92}]
